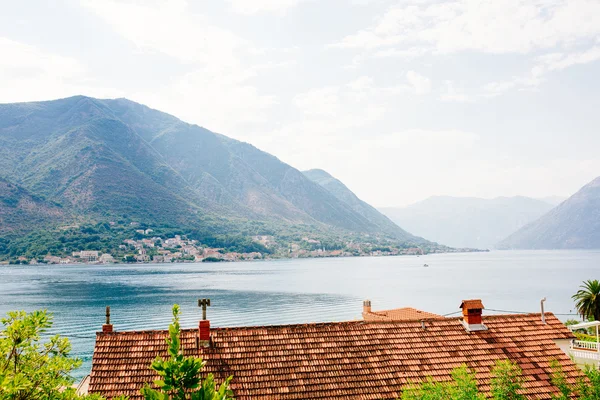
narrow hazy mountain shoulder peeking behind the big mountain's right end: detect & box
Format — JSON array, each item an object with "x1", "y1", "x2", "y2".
[{"x1": 303, "y1": 169, "x2": 422, "y2": 241}]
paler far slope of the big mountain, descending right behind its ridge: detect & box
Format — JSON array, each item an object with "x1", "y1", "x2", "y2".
[{"x1": 103, "y1": 99, "x2": 404, "y2": 233}]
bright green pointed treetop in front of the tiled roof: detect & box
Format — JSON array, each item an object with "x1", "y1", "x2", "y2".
[{"x1": 141, "y1": 304, "x2": 233, "y2": 400}]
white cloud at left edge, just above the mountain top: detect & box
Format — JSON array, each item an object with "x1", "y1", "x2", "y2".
[{"x1": 0, "y1": 37, "x2": 122, "y2": 102}]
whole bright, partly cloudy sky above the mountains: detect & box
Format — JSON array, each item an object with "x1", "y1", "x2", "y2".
[{"x1": 0, "y1": 0, "x2": 600, "y2": 206}]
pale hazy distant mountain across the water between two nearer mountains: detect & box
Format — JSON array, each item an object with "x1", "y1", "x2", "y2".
[{"x1": 380, "y1": 196, "x2": 552, "y2": 249}]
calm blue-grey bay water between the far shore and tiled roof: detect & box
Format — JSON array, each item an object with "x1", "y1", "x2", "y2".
[{"x1": 0, "y1": 251, "x2": 600, "y2": 377}]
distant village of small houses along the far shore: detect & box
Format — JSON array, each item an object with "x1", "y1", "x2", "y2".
[{"x1": 5, "y1": 229, "x2": 466, "y2": 264}]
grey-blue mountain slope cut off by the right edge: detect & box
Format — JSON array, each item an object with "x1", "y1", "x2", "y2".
[{"x1": 498, "y1": 177, "x2": 600, "y2": 249}]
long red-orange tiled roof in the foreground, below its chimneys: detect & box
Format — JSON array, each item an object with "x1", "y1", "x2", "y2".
[{"x1": 90, "y1": 313, "x2": 579, "y2": 400}]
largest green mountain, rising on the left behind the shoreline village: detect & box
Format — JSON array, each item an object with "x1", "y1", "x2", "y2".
[{"x1": 0, "y1": 96, "x2": 426, "y2": 250}]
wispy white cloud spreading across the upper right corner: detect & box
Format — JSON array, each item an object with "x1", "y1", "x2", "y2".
[{"x1": 328, "y1": 0, "x2": 600, "y2": 101}]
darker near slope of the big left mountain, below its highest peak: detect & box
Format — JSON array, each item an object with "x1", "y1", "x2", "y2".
[{"x1": 0, "y1": 97, "x2": 213, "y2": 223}]
